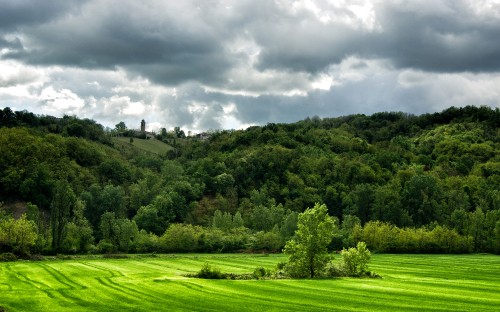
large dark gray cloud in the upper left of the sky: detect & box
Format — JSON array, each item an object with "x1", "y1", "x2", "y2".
[{"x1": 6, "y1": 1, "x2": 237, "y2": 84}]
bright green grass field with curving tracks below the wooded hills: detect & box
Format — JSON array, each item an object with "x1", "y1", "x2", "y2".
[{"x1": 0, "y1": 254, "x2": 500, "y2": 311}]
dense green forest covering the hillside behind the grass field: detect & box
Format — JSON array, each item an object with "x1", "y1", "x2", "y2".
[{"x1": 0, "y1": 106, "x2": 500, "y2": 257}]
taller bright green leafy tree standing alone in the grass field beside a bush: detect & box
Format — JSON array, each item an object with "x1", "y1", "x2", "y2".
[{"x1": 284, "y1": 203, "x2": 335, "y2": 278}]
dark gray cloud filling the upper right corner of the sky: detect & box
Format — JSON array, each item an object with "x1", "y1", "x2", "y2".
[{"x1": 377, "y1": 0, "x2": 500, "y2": 72}]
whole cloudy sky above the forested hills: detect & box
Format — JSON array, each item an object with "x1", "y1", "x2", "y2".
[{"x1": 0, "y1": 0, "x2": 500, "y2": 132}]
